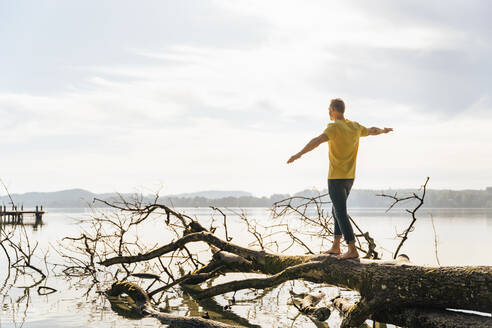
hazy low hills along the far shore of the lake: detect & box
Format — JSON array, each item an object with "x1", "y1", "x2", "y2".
[{"x1": 0, "y1": 188, "x2": 492, "y2": 208}]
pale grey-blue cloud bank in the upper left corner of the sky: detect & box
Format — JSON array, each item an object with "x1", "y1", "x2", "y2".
[{"x1": 0, "y1": 0, "x2": 268, "y2": 95}]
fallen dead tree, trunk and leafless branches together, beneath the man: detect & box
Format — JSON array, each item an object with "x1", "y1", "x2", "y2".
[{"x1": 58, "y1": 182, "x2": 492, "y2": 327}]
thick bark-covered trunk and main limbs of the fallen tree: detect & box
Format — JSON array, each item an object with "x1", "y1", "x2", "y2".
[{"x1": 101, "y1": 231, "x2": 492, "y2": 327}]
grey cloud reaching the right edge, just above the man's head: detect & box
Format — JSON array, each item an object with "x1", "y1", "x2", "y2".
[{"x1": 312, "y1": 47, "x2": 492, "y2": 117}]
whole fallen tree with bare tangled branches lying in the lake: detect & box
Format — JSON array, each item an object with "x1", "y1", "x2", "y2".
[{"x1": 58, "y1": 181, "x2": 492, "y2": 327}]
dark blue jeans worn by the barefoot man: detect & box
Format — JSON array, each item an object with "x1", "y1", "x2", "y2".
[{"x1": 328, "y1": 179, "x2": 355, "y2": 244}]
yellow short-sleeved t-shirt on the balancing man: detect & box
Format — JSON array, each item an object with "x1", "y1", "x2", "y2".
[{"x1": 323, "y1": 119, "x2": 369, "y2": 179}]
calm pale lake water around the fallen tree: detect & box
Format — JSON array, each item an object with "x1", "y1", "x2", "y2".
[{"x1": 0, "y1": 208, "x2": 492, "y2": 328}]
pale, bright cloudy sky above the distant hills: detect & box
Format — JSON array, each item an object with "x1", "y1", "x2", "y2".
[{"x1": 0, "y1": 0, "x2": 492, "y2": 196}]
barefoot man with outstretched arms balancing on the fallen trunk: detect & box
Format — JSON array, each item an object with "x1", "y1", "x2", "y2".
[{"x1": 287, "y1": 98, "x2": 393, "y2": 259}]
